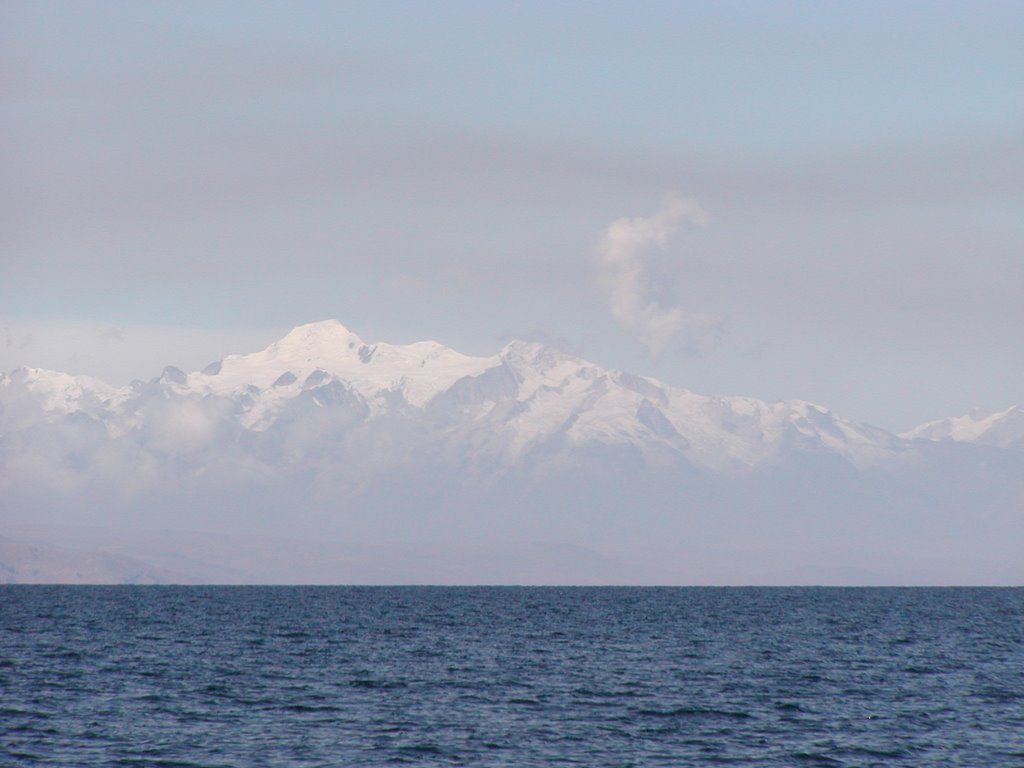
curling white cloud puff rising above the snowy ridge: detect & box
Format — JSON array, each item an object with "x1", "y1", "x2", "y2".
[{"x1": 597, "y1": 195, "x2": 722, "y2": 358}]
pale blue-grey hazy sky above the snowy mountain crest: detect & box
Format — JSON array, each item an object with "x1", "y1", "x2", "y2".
[{"x1": 0, "y1": 0, "x2": 1024, "y2": 430}]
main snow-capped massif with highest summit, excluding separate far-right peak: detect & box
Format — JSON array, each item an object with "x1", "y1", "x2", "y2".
[{"x1": 0, "y1": 321, "x2": 899, "y2": 470}]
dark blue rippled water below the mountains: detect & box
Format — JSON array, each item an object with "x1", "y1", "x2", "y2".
[{"x1": 0, "y1": 586, "x2": 1024, "y2": 768}]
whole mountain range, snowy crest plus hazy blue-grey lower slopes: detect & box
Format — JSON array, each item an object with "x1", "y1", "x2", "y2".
[{"x1": 0, "y1": 321, "x2": 1024, "y2": 583}]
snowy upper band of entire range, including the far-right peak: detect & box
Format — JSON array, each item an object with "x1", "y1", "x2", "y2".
[{"x1": 0, "y1": 319, "x2": 1011, "y2": 469}]
